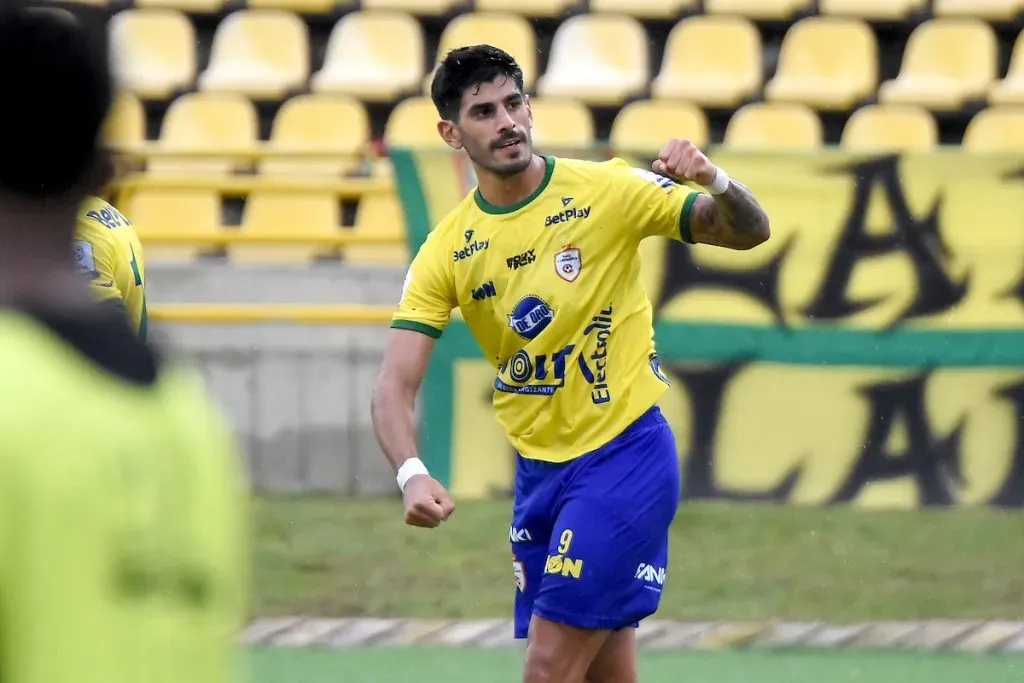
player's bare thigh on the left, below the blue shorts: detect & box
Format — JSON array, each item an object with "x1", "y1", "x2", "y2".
[{"x1": 523, "y1": 614, "x2": 609, "y2": 683}]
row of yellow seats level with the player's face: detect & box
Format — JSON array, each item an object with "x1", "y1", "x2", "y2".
[{"x1": 108, "y1": 93, "x2": 1024, "y2": 168}]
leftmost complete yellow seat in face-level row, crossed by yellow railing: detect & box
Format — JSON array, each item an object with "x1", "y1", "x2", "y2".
[{"x1": 148, "y1": 92, "x2": 258, "y2": 174}]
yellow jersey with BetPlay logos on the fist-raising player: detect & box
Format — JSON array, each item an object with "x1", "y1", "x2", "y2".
[{"x1": 391, "y1": 157, "x2": 698, "y2": 462}]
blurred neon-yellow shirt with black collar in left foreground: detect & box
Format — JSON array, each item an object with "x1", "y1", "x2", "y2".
[{"x1": 0, "y1": 309, "x2": 249, "y2": 683}]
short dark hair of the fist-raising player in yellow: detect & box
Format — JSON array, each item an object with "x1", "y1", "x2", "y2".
[{"x1": 430, "y1": 45, "x2": 523, "y2": 122}]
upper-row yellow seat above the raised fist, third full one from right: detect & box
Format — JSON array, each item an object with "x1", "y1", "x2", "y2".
[{"x1": 651, "y1": 16, "x2": 763, "y2": 108}]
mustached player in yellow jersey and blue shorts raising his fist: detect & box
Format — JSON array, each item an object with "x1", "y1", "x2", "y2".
[{"x1": 373, "y1": 45, "x2": 769, "y2": 683}]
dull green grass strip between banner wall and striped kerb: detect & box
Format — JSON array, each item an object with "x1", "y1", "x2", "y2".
[{"x1": 254, "y1": 497, "x2": 1024, "y2": 622}]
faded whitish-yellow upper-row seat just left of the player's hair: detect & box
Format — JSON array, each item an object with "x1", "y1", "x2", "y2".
[{"x1": 311, "y1": 10, "x2": 425, "y2": 101}]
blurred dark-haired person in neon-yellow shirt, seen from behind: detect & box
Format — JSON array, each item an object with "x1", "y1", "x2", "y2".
[{"x1": 0, "y1": 2, "x2": 248, "y2": 683}]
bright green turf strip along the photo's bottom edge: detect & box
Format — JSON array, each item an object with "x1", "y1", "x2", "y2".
[{"x1": 250, "y1": 648, "x2": 1024, "y2": 683}]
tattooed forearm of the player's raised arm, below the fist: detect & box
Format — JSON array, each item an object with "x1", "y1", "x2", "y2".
[{"x1": 692, "y1": 179, "x2": 771, "y2": 249}]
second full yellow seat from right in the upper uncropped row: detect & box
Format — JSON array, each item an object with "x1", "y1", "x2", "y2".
[{"x1": 765, "y1": 16, "x2": 879, "y2": 110}]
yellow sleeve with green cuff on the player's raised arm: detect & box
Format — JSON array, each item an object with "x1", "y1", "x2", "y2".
[{"x1": 609, "y1": 159, "x2": 700, "y2": 244}]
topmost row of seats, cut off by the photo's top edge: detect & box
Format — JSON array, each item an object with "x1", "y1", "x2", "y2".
[{"x1": 72, "y1": 0, "x2": 1024, "y2": 20}]
